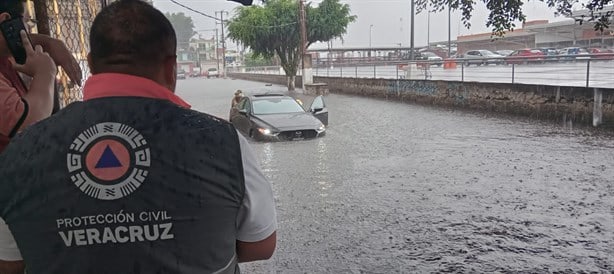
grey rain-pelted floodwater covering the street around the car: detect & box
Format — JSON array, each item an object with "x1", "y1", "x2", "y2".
[{"x1": 178, "y1": 79, "x2": 614, "y2": 273}]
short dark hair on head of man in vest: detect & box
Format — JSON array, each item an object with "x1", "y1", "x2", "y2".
[{"x1": 90, "y1": 0, "x2": 177, "y2": 77}]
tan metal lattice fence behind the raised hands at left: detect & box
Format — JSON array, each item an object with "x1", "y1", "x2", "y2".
[{"x1": 26, "y1": 0, "x2": 106, "y2": 107}]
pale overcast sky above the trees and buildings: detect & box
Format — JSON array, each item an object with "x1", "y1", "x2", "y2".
[{"x1": 154, "y1": 0, "x2": 580, "y2": 48}]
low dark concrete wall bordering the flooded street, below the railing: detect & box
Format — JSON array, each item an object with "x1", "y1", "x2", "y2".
[{"x1": 230, "y1": 74, "x2": 614, "y2": 127}]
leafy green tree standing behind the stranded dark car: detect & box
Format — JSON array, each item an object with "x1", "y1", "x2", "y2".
[{"x1": 228, "y1": 0, "x2": 356, "y2": 90}]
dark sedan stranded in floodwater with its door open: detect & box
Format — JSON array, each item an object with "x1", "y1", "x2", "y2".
[{"x1": 230, "y1": 93, "x2": 328, "y2": 141}]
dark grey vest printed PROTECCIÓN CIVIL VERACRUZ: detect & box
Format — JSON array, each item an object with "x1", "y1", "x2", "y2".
[{"x1": 0, "y1": 97, "x2": 245, "y2": 274}]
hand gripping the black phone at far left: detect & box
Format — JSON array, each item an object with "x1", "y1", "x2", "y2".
[{"x1": 13, "y1": 30, "x2": 58, "y2": 77}]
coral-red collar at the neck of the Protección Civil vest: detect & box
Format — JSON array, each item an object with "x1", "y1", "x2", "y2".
[{"x1": 83, "y1": 73, "x2": 191, "y2": 108}]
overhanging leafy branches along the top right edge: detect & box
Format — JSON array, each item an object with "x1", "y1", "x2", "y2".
[{"x1": 424, "y1": 0, "x2": 614, "y2": 36}]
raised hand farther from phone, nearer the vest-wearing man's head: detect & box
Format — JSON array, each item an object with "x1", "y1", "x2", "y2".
[{"x1": 30, "y1": 34, "x2": 83, "y2": 86}]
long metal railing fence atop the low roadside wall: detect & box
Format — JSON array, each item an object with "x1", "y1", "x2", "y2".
[{"x1": 234, "y1": 54, "x2": 614, "y2": 88}]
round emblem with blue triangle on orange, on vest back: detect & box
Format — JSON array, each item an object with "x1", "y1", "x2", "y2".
[{"x1": 67, "y1": 122, "x2": 151, "y2": 200}]
